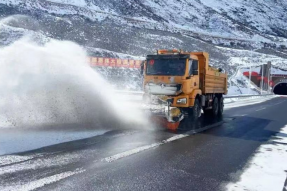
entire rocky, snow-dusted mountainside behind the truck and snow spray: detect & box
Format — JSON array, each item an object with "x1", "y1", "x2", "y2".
[{"x1": 0, "y1": 0, "x2": 287, "y2": 90}]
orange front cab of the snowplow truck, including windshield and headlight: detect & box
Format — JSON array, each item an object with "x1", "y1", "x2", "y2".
[{"x1": 144, "y1": 50, "x2": 200, "y2": 107}]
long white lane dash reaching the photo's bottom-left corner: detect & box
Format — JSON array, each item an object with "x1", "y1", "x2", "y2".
[{"x1": 0, "y1": 169, "x2": 85, "y2": 191}]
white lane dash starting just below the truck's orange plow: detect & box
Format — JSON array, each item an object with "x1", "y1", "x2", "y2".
[{"x1": 102, "y1": 134, "x2": 190, "y2": 162}]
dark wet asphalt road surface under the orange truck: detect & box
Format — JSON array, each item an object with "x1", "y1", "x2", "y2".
[{"x1": 0, "y1": 97, "x2": 287, "y2": 191}]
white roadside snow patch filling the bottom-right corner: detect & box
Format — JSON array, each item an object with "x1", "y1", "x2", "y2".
[{"x1": 227, "y1": 125, "x2": 287, "y2": 191}]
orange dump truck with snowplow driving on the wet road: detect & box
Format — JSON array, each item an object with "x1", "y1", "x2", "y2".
[{"x1": 143, "y1": 50, "x2": 227, "y2": 130}]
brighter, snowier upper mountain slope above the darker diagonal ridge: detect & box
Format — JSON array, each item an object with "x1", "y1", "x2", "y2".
[{"x1": 2, "y1": 0, "x2": 287, "y2": 42}]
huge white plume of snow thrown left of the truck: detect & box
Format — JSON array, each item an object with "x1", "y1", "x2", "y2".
[{"x1": 0, "y1": 38, "x2": 148, "y2": 128}]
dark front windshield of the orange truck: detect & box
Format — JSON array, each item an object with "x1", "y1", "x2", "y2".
[{"x1": 146, "y1": 59, "x2": 186, "y2": 76}]
